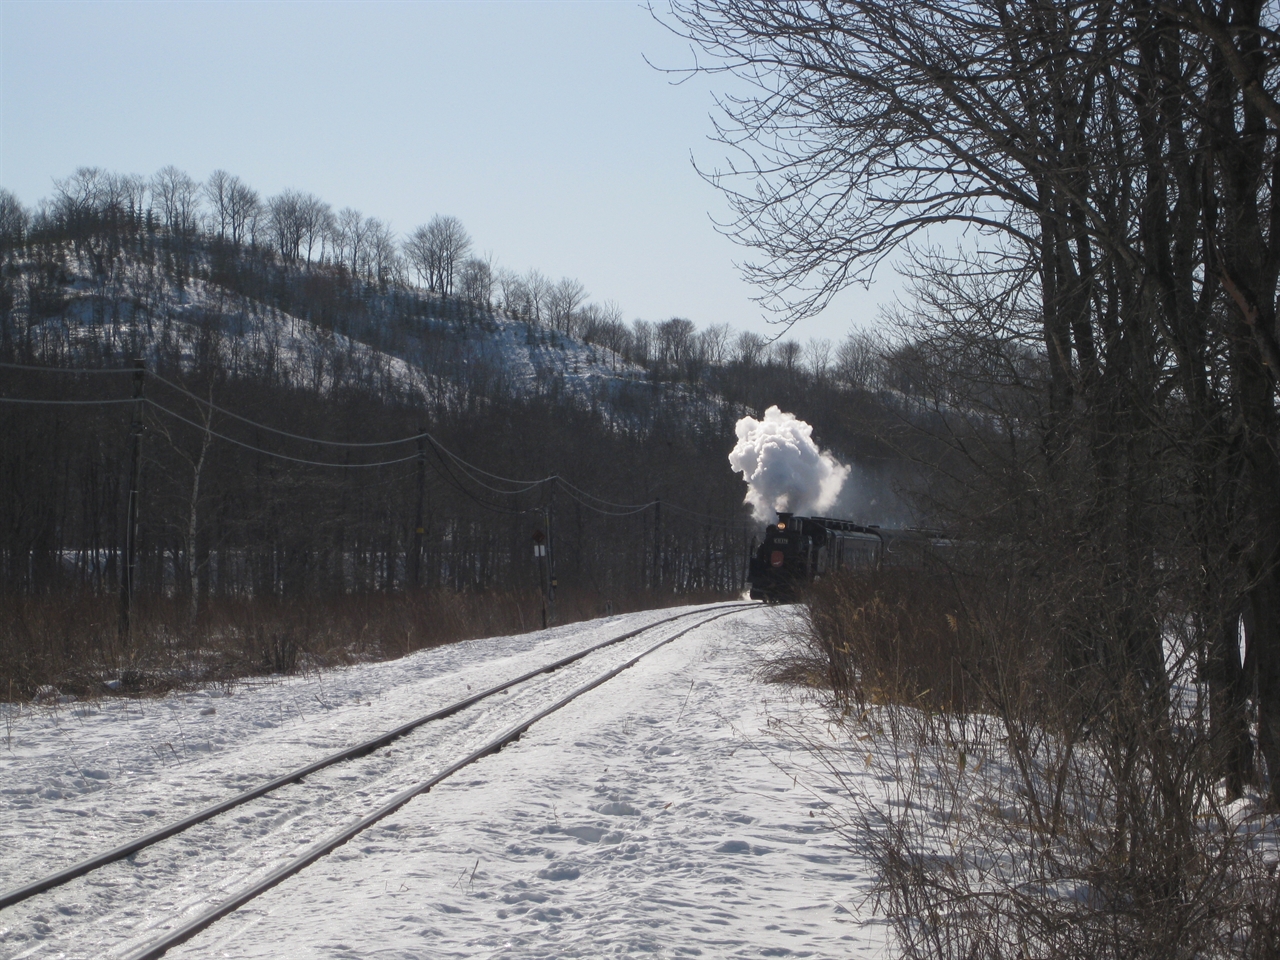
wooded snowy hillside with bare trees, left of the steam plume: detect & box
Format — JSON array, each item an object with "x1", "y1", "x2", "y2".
[{"x1": 0, "y1": 168, "x2": 905, "y2": 698}]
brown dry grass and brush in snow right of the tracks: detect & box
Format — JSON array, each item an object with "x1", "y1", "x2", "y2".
[{"x1": 790, "y1": 571, "x2": 1280, "y2": 960}]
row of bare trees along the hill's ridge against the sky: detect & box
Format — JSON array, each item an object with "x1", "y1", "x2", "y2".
[{"x1": 0, "y1": 166, "x2": 911, "y2": 390}]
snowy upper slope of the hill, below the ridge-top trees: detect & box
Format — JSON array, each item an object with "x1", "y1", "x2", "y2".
[{"x1": 20, "y1": 260, "x2": 694, "y2": 419}]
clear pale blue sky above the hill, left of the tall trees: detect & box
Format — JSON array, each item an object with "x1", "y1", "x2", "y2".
[{"x1": 0, "y1": 0, "x2": 891, "y2": 340}]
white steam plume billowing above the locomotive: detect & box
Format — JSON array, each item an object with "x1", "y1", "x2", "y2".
[{"x1": 728, "y1": 407, "x2": 850, "y2": 522}]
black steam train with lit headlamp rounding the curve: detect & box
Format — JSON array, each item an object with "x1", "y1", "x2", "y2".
[{"x1": 748, "y1": 513, "x2": 948, "y2": 603}]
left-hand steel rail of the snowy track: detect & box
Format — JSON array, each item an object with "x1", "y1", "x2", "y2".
[{"x1": 0, "y1": 604, "x2": 754, "y2": 909}]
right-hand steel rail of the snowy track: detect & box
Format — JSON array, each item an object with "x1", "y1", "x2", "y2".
[{"x1": 127, "y1": 604, "x2": 755, "y2": 960}]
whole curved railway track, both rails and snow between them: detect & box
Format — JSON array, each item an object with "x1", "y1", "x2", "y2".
[{"x1": 0, "y1": 603, "x2": 755, "y2": 960}]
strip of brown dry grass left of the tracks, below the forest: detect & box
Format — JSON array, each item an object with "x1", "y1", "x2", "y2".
[{"x1": 0, "y1": 590, "x2": 723, "y2": 700}]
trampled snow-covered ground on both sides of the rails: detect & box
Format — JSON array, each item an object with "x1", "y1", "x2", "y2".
[{"x1": 0, "y1": 607, "x2": 886, "y2": 957}]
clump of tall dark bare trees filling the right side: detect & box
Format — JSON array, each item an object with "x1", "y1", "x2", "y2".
[{"x1": 673, "y1": 0, "x2": 1280, "y2": 956}]
